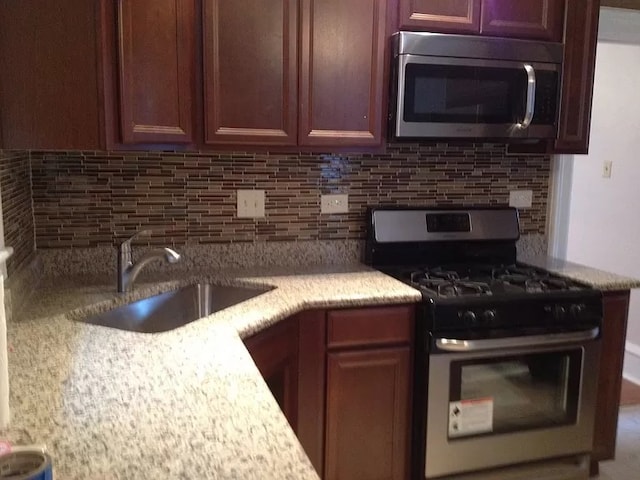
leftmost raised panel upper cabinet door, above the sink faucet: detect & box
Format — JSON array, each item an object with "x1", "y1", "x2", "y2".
[{"x1": 117, "y1": 0, "x2": 196, "y2": 144}]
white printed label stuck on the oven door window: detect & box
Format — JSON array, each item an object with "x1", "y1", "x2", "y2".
[{"x1": 449, "y1": 398, "x2": 493, "y2": 437}]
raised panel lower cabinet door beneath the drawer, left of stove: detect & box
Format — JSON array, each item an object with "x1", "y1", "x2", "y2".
[{"x1": 324, "y1": 347, "x2": 411, "y2": 480}]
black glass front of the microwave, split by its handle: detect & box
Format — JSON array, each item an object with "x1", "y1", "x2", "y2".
[{"x1": 403, "y1": 63, "x2": 558, "y2": 124}]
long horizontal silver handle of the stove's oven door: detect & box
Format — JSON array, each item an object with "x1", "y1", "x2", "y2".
[{"x1": 436, "y1": 327, "x2": 600, "y2": 352}]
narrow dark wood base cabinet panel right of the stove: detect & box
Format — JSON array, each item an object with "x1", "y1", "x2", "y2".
[{"x1": 591, "y1": 290, "x2": 629, "y2": 470}]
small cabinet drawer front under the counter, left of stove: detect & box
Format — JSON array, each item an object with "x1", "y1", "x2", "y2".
[{"x1": 327, "y1": 306, "x2": 413, "y2": 348}]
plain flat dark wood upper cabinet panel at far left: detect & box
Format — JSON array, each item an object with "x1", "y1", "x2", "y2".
[{"x1": 0, "y1": 0, "x2": 103, "y2": 150}]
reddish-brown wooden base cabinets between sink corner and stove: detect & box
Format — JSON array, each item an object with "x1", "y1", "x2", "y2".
[{"x1": 245, "y1": 306, "x2": 414, "y2": 480}]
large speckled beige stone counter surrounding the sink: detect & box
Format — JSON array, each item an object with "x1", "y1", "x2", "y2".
[{"x1": 1, "y1": 265, "x2": 420, "y2": 480}]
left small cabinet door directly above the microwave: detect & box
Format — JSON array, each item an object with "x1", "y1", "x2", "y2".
[{"x1": 399, "y1": 0, "x2": 480, "y2": 33}]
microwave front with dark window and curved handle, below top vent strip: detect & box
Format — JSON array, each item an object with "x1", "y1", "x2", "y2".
[{"x1": 392, "y1": 55, "x2": 560, "y2": 138}]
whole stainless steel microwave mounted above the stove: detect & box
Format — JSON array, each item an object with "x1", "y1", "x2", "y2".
[{"x1": 389, "y1": 32, "x2": 564, "y2": 139}]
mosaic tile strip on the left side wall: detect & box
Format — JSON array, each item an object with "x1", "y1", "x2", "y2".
[{"x1": 0, "y1": 150, "x2": 35, "y2": 277}]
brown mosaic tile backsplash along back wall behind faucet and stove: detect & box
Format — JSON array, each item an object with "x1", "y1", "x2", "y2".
[{"x1": 31, "y1": 143, "x2": 550, "y2": 249}]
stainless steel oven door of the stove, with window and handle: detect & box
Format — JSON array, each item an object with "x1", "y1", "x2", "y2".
[{"x1": 425, "y1": 328, "x2": 600, "y2": 478}]
